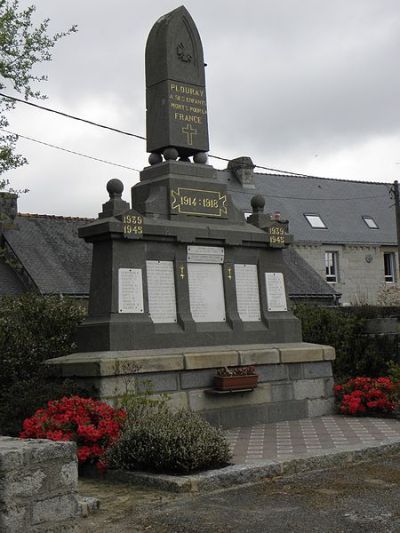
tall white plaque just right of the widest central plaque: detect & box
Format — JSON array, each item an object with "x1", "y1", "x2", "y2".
[{"x1": 235, "y1": 264, "x2": 261, "y2": 322}]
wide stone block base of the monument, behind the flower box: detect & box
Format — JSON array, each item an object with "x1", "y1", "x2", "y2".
[{"x1": 47, "y1": 342, "x2": 335, "y2": 428}]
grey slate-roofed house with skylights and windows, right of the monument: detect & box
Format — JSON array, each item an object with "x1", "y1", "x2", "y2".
[{"x1": 222, "y1": 157, "x2": 399, "y2": 305}]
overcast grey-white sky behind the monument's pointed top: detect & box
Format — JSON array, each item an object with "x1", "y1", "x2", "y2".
[{"x1": 5, "y1": 0, "x2": 400, "y2": 217}]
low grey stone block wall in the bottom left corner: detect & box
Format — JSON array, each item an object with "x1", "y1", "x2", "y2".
[{"x1": 0, "y1": 437, "x2": 79, "y2": 533}]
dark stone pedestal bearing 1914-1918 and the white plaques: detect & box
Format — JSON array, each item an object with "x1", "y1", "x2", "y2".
[{"x1": 78, "y1": 161, "x2": 301, "y2": 352}]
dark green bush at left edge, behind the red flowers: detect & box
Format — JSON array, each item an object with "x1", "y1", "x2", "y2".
[{"x1": 0, "y1": 293, "x2": 85, "y2": 435}]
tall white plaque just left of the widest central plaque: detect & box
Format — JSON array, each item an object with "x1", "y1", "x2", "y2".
[{"x1": 146, "y1": 261, "x2": 176, "y2": 324}]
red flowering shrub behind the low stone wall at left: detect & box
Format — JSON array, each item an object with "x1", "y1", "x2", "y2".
[{"x1": 20, "y1": 396, "x2": 126, "y2": 470}]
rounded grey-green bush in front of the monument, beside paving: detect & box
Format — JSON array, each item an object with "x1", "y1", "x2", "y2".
[{"x1": 107, "y1": 406, "x2": 231, "y2": 474}]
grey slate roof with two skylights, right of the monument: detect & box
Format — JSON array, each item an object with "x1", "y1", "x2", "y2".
[{"x1": 218, "y1": 170, "x2": 397, "y2": 245}]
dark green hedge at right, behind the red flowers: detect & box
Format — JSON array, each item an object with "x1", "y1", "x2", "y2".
[{"x1": 295, "y1": 305, "x2": 398, "y2": 381}]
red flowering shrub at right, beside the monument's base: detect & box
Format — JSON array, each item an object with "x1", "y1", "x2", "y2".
[{"x1": 334, "y1": 378, "x2": 400, "y2": 415}]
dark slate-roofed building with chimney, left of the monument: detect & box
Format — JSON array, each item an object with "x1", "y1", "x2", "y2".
[{"x1": 0, "y1": 193, "x2": 91, "y2": 298}]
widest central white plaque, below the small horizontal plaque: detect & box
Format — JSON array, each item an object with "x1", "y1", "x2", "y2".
[{"x1": 188, "y1": 263, "x2": 225, "y2": 322}]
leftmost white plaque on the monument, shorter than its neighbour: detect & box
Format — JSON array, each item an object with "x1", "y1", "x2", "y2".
[{"x1": 118, "y1": 268, "x2": 144, "y2": 313}]
